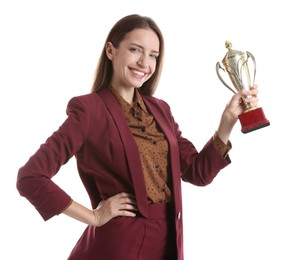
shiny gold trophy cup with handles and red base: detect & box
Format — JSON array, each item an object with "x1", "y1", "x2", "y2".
[{"x1": 216, "y1": 41, "x2": 270, "y2": 134}]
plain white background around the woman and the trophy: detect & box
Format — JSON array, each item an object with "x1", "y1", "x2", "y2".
[{"x1": 0, "y1": 0, "x2": 283, "y2": 260}]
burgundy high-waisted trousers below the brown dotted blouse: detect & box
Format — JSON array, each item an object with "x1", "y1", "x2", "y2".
[{"x1": 68, "y1": 204, "x2": 177, "y2": 260}]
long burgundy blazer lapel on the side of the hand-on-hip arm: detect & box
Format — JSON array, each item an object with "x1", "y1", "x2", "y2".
[{"x1": 97, "y1": 88, "x2": 148, "y2": 217}]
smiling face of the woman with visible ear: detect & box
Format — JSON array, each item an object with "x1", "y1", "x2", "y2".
[{"x1": 106, "y1": 29, "x2": 159, "y2": 90}]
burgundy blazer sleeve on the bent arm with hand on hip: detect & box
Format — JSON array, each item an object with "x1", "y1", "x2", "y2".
[{"x1": 17, "y1": 98, "x2": 89, "y2": 220}]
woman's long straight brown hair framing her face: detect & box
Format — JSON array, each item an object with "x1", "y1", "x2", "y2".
[{"x1": 91, "y1": 14, "x2": 164, "y2": 95}]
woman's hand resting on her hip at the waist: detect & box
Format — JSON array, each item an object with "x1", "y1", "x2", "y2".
[{"x1": 92, "y1": 192, "x2": 138, "y2": 227}]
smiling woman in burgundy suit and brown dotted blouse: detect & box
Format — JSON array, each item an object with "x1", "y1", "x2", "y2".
[{"x1": 17, "y1": 15, "x2": 257, "y2": 260}]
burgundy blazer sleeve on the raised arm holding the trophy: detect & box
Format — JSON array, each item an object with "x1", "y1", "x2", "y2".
[{"x1": 159, "y1": 98, "x2": 231, "y2": 186}]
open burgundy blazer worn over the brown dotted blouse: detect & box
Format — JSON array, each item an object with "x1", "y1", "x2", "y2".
[{"x1": 17, "y1": 88, "x2": 230, "y2": 259}]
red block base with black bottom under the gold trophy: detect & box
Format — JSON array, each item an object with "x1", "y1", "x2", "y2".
[{"x1": 239, "y1": 107, "x2": 270, "y2": 134}]
